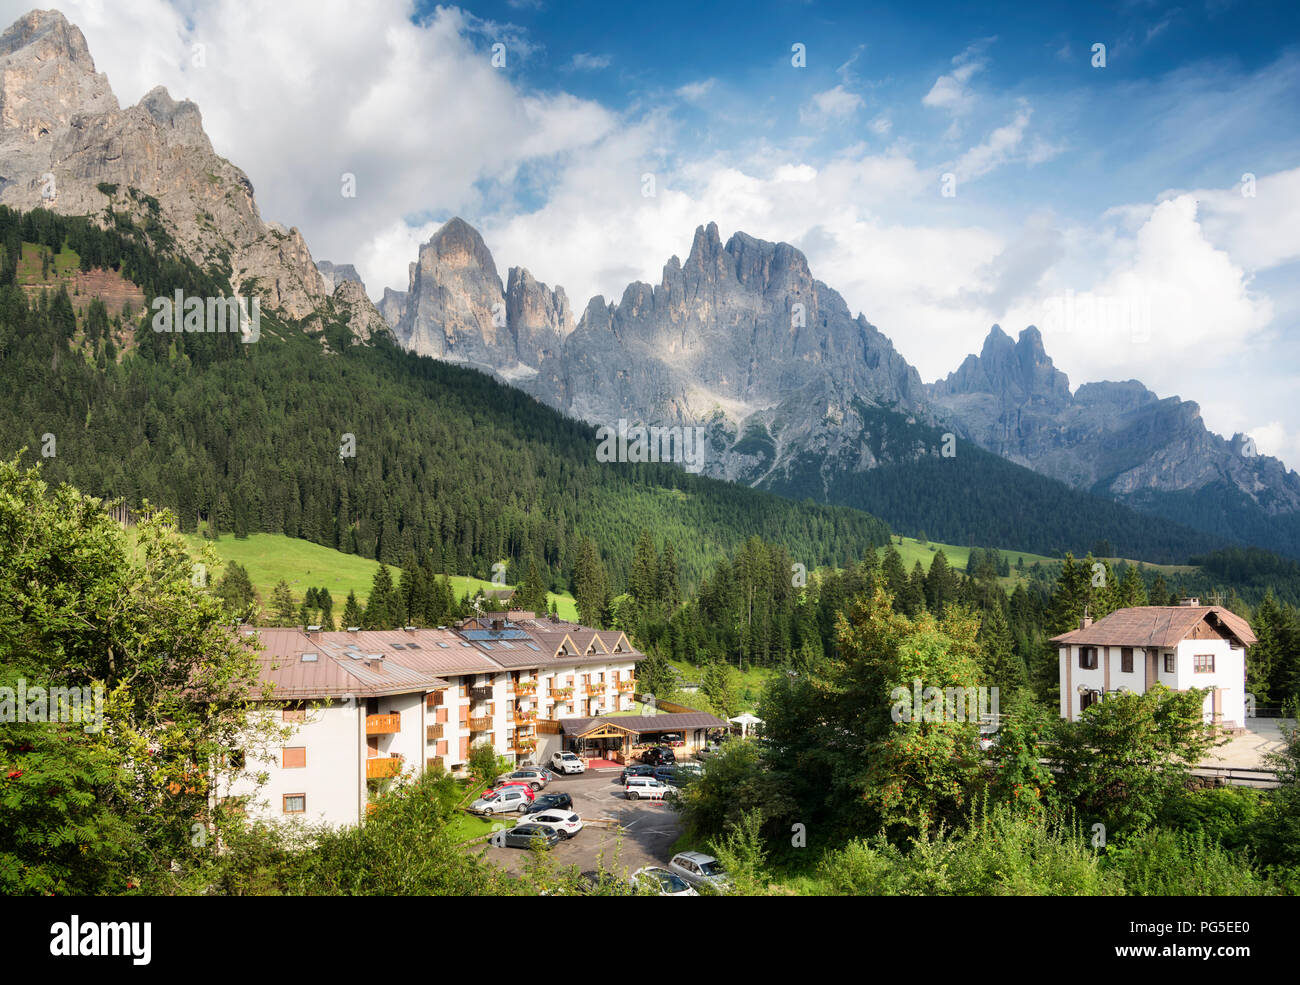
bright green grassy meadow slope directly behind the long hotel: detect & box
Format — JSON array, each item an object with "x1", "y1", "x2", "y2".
[{"x1": 133, "y1": 534, "x2": 577, "y2": 620}]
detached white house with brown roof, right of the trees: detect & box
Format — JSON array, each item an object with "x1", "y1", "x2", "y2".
[{"x1": 1052, "y1": 599, "x2": 1256, "y2": 728}]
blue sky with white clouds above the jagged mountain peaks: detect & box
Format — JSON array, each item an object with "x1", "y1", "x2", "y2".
[{"x1": 10, "y1": 0, "x2": 1300, "y2": 465}]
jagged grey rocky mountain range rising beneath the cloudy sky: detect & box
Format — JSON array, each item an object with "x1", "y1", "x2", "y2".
[{"x1": 10, "y1": 12, "x2": 1300, "y2": 555}]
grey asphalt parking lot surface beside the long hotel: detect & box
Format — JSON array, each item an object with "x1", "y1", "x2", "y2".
[{"x1": 473, "y1": 769, "x2": 681, "y2": 873}]
